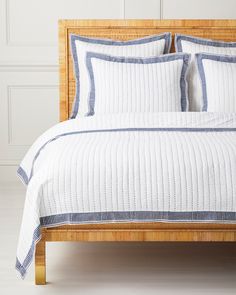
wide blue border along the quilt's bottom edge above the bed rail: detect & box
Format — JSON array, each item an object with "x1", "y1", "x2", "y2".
[{"x1": 15, "y1": 211, "x2": 236, "y2": 278}]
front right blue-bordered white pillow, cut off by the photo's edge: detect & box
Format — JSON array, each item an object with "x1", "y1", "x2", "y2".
[{"x1": 196, "y1": 53, "x2": 236, "y2": 113}]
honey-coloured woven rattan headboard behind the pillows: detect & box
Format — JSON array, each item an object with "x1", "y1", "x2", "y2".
[{"x1": 59, "y1": 20, "x2": 236, "y2": 121}]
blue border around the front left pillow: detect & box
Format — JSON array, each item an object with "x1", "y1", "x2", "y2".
[{"x1": 86, "y1": 52, "x2": 190, "y2": 116}]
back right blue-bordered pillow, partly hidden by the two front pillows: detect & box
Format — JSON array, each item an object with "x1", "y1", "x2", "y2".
[{"x1": 175, "y1": 34, "x2": 236, "y2": 112}]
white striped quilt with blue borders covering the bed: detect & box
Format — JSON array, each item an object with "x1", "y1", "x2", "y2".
[{"x1": 16, "y1": 113, "x2": 236, "y2": 277}]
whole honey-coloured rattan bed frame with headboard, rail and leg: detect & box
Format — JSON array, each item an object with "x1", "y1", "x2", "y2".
[{"x1": 35, "y1": 20, "x2": 236, "y2": 285}]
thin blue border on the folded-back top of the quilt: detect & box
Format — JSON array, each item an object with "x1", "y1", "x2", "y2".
[{"x1": 18, "y1": 127, "x2": 236, "y2": 185}]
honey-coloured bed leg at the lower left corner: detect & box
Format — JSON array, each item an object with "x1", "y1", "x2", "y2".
[{"x1": 35, "y1": 232, "x2": 46, "y2": 285}]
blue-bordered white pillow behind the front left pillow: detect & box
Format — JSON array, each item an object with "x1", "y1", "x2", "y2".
[{"x1": 71, "y1": 33, "x2": 171, "y2": 118}]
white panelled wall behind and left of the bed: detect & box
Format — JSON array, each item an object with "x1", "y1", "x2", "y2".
[{"x1": 0, "y1": 0, "x2": 236, "y2": 183}]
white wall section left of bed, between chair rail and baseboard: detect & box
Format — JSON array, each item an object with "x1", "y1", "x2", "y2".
[{"x1": 0, "y1": 66, "x2": 59, "y2": 165}]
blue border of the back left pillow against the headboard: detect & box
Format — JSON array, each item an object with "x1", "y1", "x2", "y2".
[{"x1": 70, "y1": 33, "x2": 172, "y2": 119}]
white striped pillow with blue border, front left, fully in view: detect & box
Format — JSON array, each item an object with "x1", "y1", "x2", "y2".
[{"x1": 86, "y1": 52, "x2": 190, "y2": 115}]
